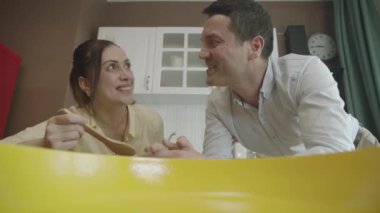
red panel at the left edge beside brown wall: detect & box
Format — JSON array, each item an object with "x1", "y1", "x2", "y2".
[{"x1": 0, "y1": 44, "x2": 21, "y2": 138}]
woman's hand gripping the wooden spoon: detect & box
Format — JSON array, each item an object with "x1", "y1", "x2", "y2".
[{"x1": 44, "y1": 107, "x2": 86, "y2": 150}]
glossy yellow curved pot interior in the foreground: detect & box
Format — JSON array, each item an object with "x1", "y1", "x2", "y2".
[{"x1": 0, "y1": 143, "x2": 380, "y2": 213}]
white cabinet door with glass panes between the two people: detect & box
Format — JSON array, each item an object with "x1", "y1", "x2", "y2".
[{"x1": 153, "y1": 27, "x2": 211, "y2": 95}]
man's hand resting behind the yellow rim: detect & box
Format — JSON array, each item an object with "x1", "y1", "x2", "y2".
[{"x1": 150, "y1": 136, "x2": 206, "y2": 159}]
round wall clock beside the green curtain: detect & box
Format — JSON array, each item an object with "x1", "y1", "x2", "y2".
[{"x1": 307, "y1": 33, "x2": 337, "y2": 60}]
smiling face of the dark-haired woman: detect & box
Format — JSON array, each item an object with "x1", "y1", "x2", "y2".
[{"x1": 95, "y1": 45, "x2": 135, "y2": 105}]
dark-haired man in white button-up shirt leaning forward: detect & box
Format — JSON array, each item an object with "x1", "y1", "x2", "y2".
[{"x1": 151, "y1": 0, "x2": 378, "y2": 159}]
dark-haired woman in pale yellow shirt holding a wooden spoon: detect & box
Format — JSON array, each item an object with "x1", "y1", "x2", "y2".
[{"x1": 4, "y1": 40, "x2": 163, "y2": 156}]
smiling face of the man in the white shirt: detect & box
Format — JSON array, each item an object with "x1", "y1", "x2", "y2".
[{"x1": 199, "y1": 15, "x2": 248, "y2": 86}]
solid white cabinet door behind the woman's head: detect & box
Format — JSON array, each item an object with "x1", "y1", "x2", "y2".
[{"x1": 98, "y1": 27, "x2": 156, "y2": 94}]
